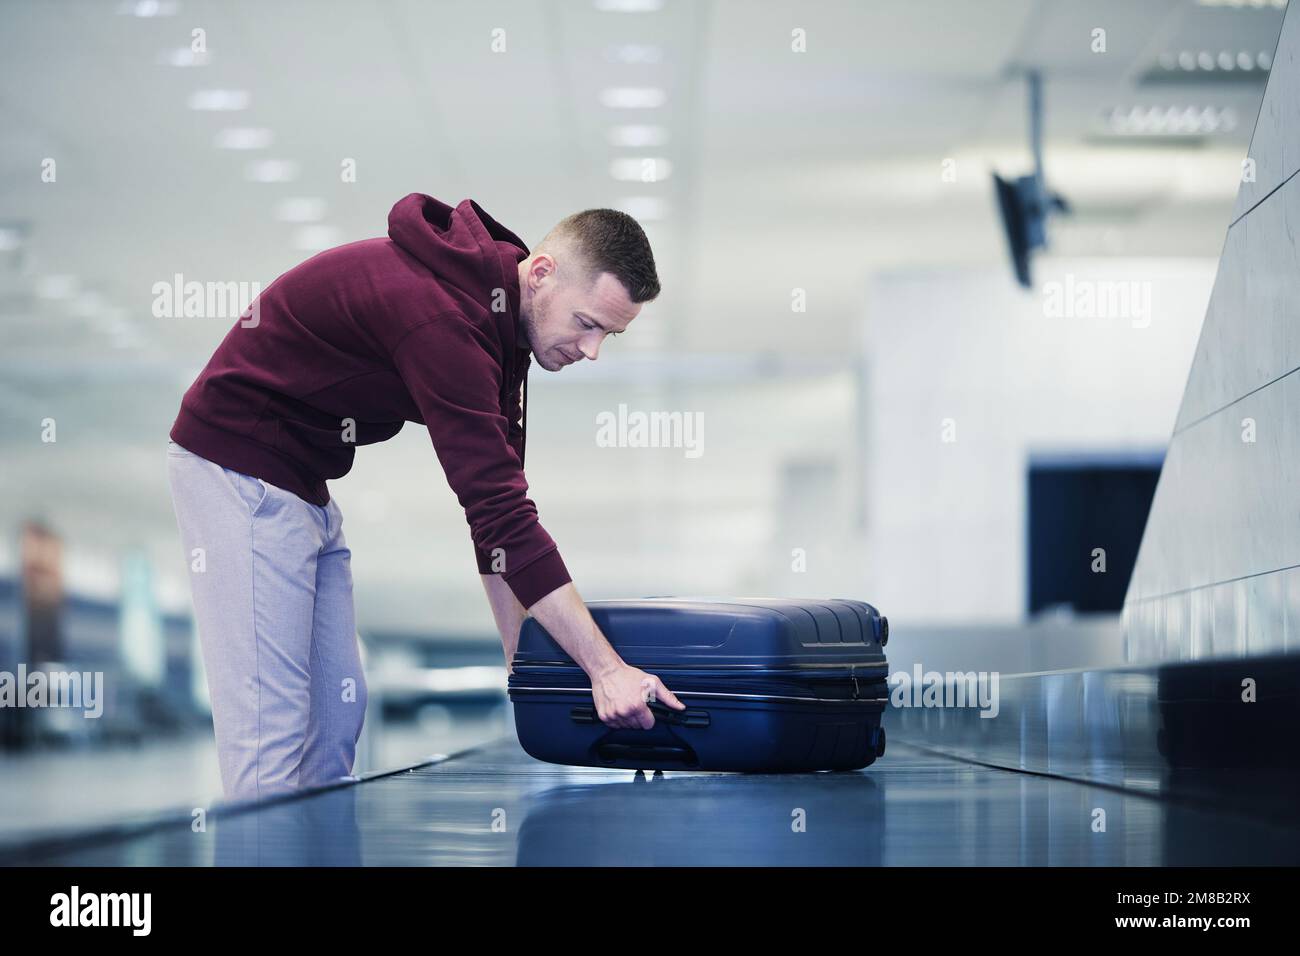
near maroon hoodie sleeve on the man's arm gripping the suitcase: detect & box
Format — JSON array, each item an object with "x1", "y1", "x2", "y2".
[{"x1": 393, "y1": 313, "x2": 572, "y2": 607}]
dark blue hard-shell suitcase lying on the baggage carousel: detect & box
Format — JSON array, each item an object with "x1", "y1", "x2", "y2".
[{"x1": 508, "y1": 598, "x2": 889, "y2": 773}]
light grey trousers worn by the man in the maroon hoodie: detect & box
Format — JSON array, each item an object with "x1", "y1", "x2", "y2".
[{"x1": 168, "y1": 440, "x2": 367, "y2": 800}]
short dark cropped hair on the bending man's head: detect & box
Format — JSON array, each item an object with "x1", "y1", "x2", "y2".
[{"x1": 536, "y1": 209, "x2": 659, "y2": 302}]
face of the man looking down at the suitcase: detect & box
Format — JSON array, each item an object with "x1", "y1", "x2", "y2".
[{"x1": 520, "y1": 252, "x2": 641, "y2": 372}]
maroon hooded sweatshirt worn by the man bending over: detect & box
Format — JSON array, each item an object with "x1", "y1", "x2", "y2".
[{"x1": 172, "y1": 193, "x2": 571, "y2": 607}]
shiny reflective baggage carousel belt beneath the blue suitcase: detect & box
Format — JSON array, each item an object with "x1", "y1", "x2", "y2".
[{"x1": 0, "y1": 737, "x2": 1300, "y2": 866}]
